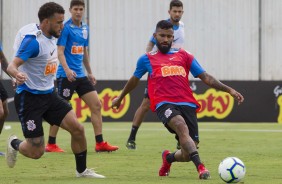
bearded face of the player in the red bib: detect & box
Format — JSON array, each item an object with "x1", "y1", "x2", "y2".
[{"x1": 154, "y1": 28, "x2": 173, "y2": 54}]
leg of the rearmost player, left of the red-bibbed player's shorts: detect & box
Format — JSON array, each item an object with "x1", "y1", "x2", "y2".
[{"x1": 126, "y1": 87, "x2": 150, "y2": 150}]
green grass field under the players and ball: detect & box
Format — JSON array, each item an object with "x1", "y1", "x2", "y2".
[{"x1": 0, "y1": 123, "x2": 282, "y2": 184}]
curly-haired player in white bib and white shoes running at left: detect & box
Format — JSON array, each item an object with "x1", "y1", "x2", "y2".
[{"x1": 6, "y1": 2, "x2": 104, "y2": 178}]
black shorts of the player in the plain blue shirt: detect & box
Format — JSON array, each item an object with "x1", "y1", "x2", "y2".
[{"x1": 57, "y1": 77, "x2": 96, "y2": 101}]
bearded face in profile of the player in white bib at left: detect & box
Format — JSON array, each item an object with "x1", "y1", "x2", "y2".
[{"x1": 49, "y1": 13, "x2": 64, "y2": 38}]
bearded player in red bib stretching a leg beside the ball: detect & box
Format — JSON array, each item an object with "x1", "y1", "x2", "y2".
[{"x1": 112, "y1": 20, "x2": 244, "y2": 179}]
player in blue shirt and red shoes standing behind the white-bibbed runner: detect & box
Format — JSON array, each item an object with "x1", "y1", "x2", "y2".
[{"x1": 45, "y1": 0, "x2": 118, "y2": 152}]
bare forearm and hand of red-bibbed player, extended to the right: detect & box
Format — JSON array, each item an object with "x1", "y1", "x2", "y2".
[{"x1": 198, "y1": 72, "x2": 244, "y2": 104}]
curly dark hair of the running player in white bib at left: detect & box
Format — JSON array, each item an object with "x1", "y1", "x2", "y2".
[{"x1": 38, "y1": 2, "x2": 65, "y2": 23}]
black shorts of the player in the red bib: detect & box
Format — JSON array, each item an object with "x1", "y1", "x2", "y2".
[{"x1": 156, "y1": 103, "x2": 199, "y2": 142}]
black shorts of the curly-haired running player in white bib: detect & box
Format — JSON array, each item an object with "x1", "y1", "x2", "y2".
[{"x1": 15, "y1": 91, "x2": 72, "y2": 138}]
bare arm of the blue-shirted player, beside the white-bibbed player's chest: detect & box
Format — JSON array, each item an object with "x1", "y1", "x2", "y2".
[{"x1": 58, "y1": 45, "x2": 76, "y2": 82}]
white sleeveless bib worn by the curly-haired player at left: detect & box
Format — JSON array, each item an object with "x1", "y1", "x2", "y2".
[{"x1": 13, "y1": 23, "x2": 58, "y2": 91}]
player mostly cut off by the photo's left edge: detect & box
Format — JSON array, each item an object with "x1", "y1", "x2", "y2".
[{"x1": 0, "y1": 42, "x2": 14, "y2": 156}]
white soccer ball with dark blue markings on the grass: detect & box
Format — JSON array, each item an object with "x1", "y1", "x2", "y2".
[{"x1": 218, "y1": 157, "x2": 246, "y2": 183}]
